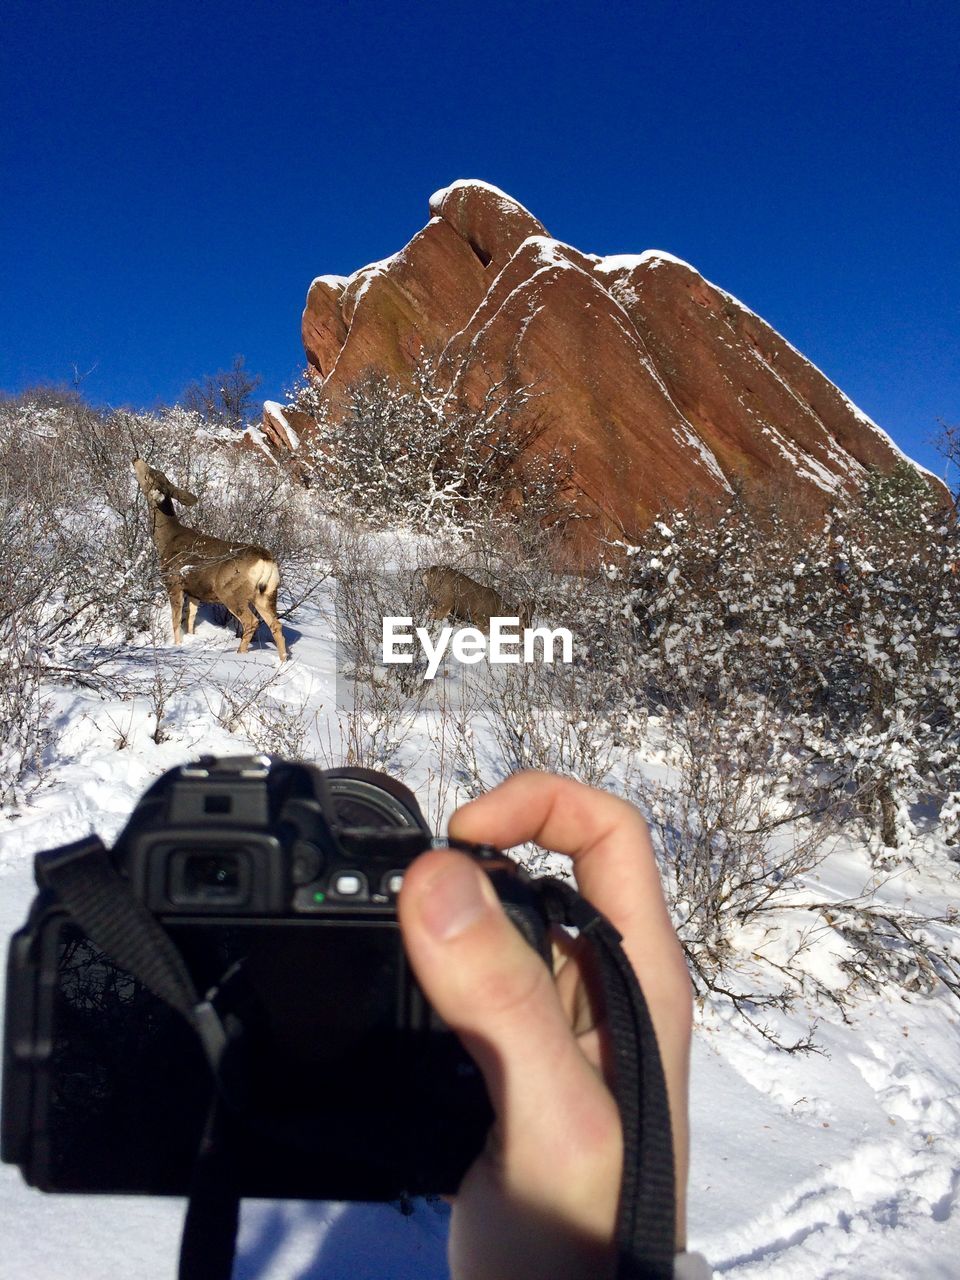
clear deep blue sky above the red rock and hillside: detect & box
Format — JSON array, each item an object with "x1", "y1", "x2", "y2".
[{"x1": 0, "y1": 0, "x2": 960, "y2": 481}]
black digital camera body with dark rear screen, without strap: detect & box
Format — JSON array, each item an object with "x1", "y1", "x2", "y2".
[{"x1": 0, "y1": 756, "x2": 549, "y2": 1201}]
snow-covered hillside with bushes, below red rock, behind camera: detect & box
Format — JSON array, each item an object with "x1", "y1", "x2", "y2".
[{"x1": 0, "y1": 393, "x2": 960, "y2": 1280}]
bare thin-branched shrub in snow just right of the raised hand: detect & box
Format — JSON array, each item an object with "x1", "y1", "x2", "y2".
[{"x1": 636, "y1": 700, "x2": 836, "y2": 1048}]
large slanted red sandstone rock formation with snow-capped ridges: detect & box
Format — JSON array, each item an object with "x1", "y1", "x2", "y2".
[{"x1": 284, "y1": 182, "x2": 942, "y2": 538}]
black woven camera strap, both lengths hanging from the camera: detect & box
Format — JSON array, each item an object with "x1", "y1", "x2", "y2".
[{"x1": 36, "y1": 836, "x2": 675, "y2": 1280}]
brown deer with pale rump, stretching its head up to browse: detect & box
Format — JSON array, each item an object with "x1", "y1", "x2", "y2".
[{"x1": 133, "y1": 458, "x2": 287, "y2": 662}]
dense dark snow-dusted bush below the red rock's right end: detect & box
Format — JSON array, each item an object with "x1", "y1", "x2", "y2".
[{"x1": 612, "y1": 476, "x2": 960, "y2": 846}]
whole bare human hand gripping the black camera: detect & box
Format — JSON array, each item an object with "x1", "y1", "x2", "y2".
[{"x1": 399, "y1": 772, "x2": 692, "y2": 1280}]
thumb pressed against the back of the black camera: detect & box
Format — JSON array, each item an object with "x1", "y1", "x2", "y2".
[{"x1": 398, "y1": 850, "x2": 621, "y2": 1187}]
